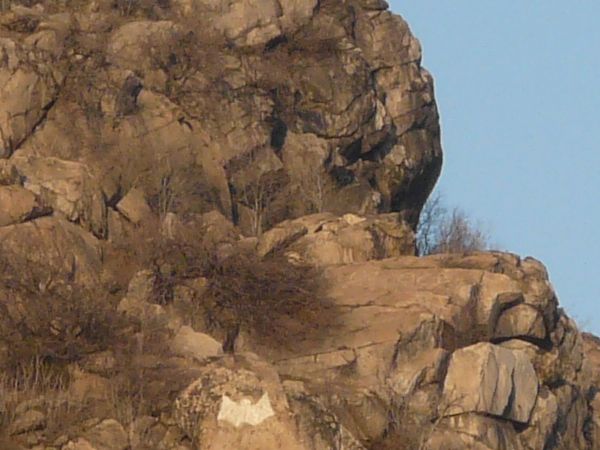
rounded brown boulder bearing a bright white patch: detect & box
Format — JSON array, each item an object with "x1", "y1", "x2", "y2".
[{"x1": 175, "y1": 355, "x2": 362, "y2": 450}]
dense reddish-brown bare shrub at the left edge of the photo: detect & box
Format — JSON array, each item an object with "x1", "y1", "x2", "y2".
[{"x1": 0, "y1": 253, "x2": 123, "y2": 369}]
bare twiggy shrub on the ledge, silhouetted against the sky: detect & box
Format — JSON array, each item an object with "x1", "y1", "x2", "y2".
[{"x1": 417, "y1": 194, "x2": 490, "y2": 255}]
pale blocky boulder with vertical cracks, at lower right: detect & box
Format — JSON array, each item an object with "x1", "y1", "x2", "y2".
[{"x1": 440, "y1": 343, "x2": 538, "y2": 423}]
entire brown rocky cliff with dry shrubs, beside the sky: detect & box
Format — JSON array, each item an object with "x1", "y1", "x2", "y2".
[{"x1": 0, "y1": 0, "x2": 600, "y2": 450}]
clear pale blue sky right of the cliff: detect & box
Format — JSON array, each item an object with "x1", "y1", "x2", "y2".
[{"x1": 390, "y1": 0, "x2": 600, "y2": 334}]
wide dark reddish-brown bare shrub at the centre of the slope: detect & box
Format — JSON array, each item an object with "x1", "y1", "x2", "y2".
[{"x1": 144, "y1": 230, "x2": 333, "y2": 350}]
